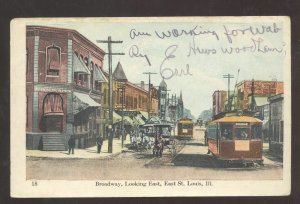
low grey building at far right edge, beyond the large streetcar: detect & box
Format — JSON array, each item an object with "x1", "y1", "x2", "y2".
[{"x1": 269, "y1": 94, "x2": 284, "y2": 157}]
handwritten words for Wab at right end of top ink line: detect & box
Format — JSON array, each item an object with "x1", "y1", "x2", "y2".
[{"x1": 223, "y1": 23, "x2": 282, "y2": 43}]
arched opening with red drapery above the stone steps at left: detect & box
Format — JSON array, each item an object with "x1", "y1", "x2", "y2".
[{"x1": 41, "y1": 93, "x2": 64, "y2": 132}]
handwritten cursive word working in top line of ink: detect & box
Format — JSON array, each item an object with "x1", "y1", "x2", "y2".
[{"x1": 155, "y1": 26, "x2": 219, "y2": 40}]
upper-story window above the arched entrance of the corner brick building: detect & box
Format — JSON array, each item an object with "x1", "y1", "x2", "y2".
[{"x1": 46, "y1": 45, "x2": 61, "y2": 76}]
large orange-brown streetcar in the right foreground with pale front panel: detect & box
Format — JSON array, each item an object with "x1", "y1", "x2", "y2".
[{"x1": 206, "y1": 116, "x2": 263, "y2": 165}]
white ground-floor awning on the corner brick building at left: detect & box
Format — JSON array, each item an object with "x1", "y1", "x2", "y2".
[{"x1": 73, "y1": 92, "x2": 101, "y2": 114}]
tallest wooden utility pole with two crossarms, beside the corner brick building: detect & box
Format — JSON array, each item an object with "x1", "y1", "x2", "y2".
[{"x1": 97, "y1": 36, "x2": 124, "y2": 153}]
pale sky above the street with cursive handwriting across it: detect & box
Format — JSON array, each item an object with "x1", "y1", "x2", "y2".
[{"x1": 27, "y1": 18, "x2": 289, "y2": 117}]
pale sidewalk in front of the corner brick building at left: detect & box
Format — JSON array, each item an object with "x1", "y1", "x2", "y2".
[{"x1": 26, "y1": 135, "x2": 130, "y2": 159}]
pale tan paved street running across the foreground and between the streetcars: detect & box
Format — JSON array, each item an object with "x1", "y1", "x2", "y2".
[{"x1": 27, "y1": 127, "x2": 282, "y2": 180}]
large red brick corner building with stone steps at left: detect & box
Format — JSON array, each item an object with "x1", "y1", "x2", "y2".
[{"x1": 26, "y1": 26, "x2": 106, "y2": 150}]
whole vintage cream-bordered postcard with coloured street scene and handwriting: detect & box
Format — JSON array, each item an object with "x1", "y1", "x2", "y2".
[{"x1": 10, "y1": 16, "x2": 292, "y2": 197}]
